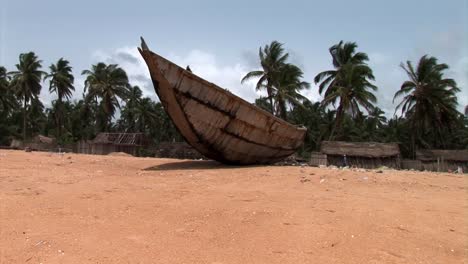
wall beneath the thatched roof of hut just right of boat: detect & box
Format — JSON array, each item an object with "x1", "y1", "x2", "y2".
[{"x1": 327, "y1": 155, "x2": 400, "y2": 169}]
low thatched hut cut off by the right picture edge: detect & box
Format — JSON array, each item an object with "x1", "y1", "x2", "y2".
[{"x1": 416, "y1": 149, "x2": 468, "y2": 172}]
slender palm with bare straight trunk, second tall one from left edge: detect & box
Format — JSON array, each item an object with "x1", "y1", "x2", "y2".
[{"x1": 44, "y1": 58, "x2": 75, "y2": 138}]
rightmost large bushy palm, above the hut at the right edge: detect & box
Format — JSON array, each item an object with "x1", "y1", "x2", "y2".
[{"x1": 393, "y1": 55, "x2": 460, "y2": 152}]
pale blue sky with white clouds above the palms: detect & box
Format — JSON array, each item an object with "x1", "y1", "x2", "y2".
[{"x1": 0, "y1": 0, "x2": 468, "y2": 115}]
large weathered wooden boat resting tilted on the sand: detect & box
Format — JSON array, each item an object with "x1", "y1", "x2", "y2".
[{"x1": 138, "y1": 39, "x2": 307, "y2": 164}]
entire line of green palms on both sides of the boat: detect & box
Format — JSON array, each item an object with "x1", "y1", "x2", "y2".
[{"x1": 0, "y1": 41, "x2": 468, "y2": 157}]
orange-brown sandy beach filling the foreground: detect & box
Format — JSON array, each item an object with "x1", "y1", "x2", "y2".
[{"x1": 0, "y1": 150, "x2": 468, "y2": 264}]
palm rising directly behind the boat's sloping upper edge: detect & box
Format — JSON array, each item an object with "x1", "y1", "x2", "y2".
[{"x1": 241, "y1": 41, "x2": 289, "y2": 113}]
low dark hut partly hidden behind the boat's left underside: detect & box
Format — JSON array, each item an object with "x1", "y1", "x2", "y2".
[{"x1": 155, "y1": 142, "x2": 204, "y2": 159}]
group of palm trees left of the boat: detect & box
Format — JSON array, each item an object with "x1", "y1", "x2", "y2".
[{"x1": 0, "y1": 52, "x2": 181, "y2": 145}]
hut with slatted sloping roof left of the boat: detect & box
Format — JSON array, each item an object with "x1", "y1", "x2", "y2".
[{"x1": 76, "y1": 133, "x2": 149, "y2": 156}]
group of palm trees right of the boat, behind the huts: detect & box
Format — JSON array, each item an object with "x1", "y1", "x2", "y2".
[{"x1": 247, "y1": 41, "x2": 468, "y2": 156}]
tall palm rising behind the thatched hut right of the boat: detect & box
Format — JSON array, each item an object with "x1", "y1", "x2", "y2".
[{"x1": 314, "y1": 41, "x2": 377, "y2": 140}]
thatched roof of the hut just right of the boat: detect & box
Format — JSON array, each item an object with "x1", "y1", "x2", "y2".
[{"x1": 321, "y1": 141, "x2": 400, "y2": 158}]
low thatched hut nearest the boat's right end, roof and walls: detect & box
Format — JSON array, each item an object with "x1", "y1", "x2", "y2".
[{"x1": 320, "y1": 141, "x2": 400, "y2": 169}]
